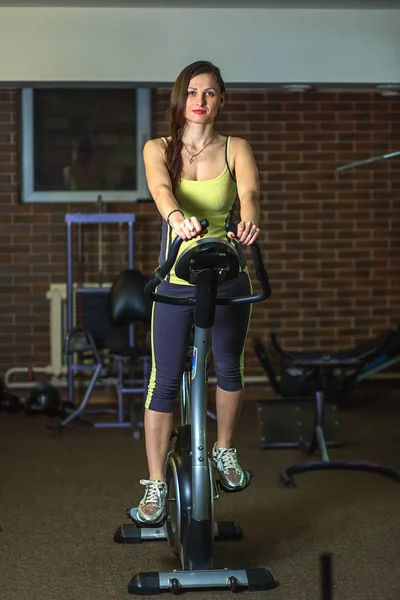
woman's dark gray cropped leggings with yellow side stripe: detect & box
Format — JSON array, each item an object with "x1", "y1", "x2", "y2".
[{"x1": 146, "y1": 273, "x2": 251, "y2": 413}]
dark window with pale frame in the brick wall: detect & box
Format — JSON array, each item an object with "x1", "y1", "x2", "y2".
[{"x1": 21, "y1": 88, "x2": 151, "y2": 202}]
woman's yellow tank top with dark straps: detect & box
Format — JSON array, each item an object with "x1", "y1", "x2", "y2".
[{"x1": 159, "y1": 137, "x2": 241, "y2": 285}]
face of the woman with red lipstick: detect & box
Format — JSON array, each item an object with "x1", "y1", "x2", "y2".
[{"x1": 185, "y1": 73, "x2": 225, "y2": 125}]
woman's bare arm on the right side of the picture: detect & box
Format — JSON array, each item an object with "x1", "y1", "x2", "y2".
[{"x1": 230, "y1": 138, "x2": 260, "y2": 245}]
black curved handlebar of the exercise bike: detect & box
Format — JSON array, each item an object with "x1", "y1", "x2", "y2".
[{"x1": 144, "y1": 219, "x2": 271, "y2": 306}]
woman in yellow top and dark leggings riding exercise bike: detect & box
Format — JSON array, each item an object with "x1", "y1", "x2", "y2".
[{"x1": 138, "y1": 61, "x2": 260, "y2": 525}]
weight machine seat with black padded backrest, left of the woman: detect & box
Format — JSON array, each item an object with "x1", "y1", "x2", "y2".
[{"x1": 58, "y1": 269, "x2": 152, "y2": 439}]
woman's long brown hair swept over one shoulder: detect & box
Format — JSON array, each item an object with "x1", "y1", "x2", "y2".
[{"x1": 166, "y1": 60, "x2": 225, "y2": 189}]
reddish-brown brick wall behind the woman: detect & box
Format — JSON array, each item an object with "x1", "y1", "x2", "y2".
[{"x1": 0, "y1": 89, "x2": 400, "y2": 384}]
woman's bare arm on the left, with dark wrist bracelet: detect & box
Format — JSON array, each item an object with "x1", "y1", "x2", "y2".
[{"x1": 143, "y1": 139, "x2": 203, "y2": 240}]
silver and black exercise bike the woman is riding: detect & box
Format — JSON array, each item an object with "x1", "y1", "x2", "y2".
[{"x1": 114, "y1": 220, "x2": 277, "y2": 595}]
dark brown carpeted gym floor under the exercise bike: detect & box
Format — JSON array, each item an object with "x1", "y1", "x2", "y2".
[{"x1": 0, "y1": 390, "x2": 400, "y2": 600}]
